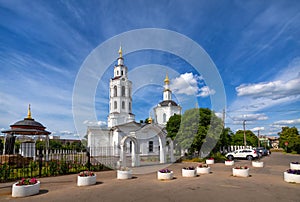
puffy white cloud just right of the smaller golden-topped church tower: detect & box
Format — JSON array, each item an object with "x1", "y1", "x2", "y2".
[{"x1": 170, "y1": 73, "x2": 216, "y2": 97}]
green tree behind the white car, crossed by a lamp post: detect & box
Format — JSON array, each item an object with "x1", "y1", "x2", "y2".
[{"x1": 231, "y1": 130, "x2": 258, "y2": 147}]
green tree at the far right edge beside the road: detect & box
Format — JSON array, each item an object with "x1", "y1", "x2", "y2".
[{"x1": 278, "y1": 127, "x2": 300, "y2": 154}]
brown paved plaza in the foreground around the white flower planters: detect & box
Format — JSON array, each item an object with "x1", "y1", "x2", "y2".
[{"x1": 0, "y1": 153, "x2": 300, "y2": 202}]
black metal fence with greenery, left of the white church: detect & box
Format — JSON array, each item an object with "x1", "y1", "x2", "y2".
[{"x1": 0, "y1": 149, "x2": 110, "y2": 182}]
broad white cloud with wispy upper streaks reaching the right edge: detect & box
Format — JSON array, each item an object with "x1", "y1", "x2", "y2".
[{"x1": 228, "y1": 57, "x2": 300, "y2": 117}]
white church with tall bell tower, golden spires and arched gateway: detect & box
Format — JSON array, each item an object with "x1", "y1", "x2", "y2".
[{"x1": 87, "y1": 47, "x2": 181, "y2": 166}]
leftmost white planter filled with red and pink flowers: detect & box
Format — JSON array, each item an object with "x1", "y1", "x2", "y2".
[{"x1": 12, "y1": 178, "x2": 40, "y2": 197}]
